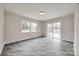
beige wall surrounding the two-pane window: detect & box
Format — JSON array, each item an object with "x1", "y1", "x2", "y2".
[{"x1": 5, "y1": 12, "x2": 42, "y2": 43}]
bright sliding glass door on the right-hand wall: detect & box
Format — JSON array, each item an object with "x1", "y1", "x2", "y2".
[{"x1": 47, "y1": 22, "x2": 61, "y2": 39}]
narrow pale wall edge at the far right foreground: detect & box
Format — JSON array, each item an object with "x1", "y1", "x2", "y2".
[{"x1": 74, "y1": 5, "x2": 79, "y2": 56}]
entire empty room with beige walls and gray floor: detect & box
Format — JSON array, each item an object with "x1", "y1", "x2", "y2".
[{"x1": 0, "y1": 3, "x2": 79, "y2": 56}]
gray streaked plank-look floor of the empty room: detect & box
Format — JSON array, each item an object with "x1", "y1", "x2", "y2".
[{"x1": 2, "y1": 37, "x2": 74, "y2": 56}]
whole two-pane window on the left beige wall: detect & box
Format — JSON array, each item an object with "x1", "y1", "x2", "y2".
[{"x1": 21, "y1": 20, "x2": 37, "y2": 32}]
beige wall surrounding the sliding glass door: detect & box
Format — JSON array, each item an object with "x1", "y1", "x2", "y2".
[{"x1": 43, "y1": 15, "x2": 74, "y2": 42}]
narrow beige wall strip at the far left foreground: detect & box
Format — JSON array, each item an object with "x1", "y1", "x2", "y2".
[{"x1": 0, "y1": 4, "x2": 4, "y2": 54}]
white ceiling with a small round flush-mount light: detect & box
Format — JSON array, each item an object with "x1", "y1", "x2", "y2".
[{"x1": 5, "y1": 3, "x2": 75, "y2": 20}]
